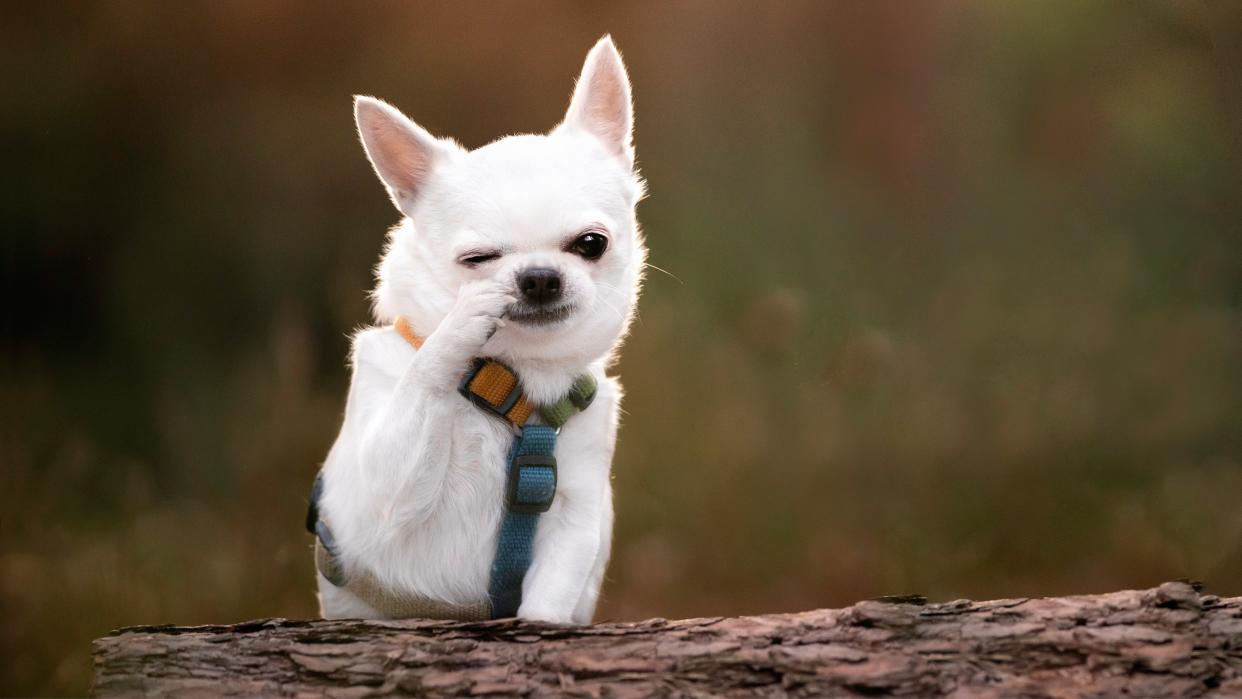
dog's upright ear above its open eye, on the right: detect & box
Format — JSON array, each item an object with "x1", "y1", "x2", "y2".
[{"x1": 561, "y1": 36, "x2": 633, "y2": 166}]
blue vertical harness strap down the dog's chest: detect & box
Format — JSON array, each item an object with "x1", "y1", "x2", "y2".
[{"x1": 488, "y1": 425, "x2": 556, "y2": 618}]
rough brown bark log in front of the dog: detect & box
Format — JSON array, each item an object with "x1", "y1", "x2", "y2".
[{"x1": 94, "y1": 582, "x2": 1242, "y2": 698}]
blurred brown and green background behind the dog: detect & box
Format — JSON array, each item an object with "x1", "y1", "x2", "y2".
[{"x1": 0, "y1": 0, "x2": 1242, "y2": 694}]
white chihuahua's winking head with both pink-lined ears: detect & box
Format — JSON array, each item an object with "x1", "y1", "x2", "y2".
[{"x1": 354, "y1": 37, "x2": 646, "y2": 369}]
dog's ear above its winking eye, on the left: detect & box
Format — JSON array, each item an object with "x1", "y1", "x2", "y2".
[{"x1": 354, "y1": 96, "x2": 453, "y2": 214}]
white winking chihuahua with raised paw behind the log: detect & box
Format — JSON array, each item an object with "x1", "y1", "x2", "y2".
[{"x1": 308, "y1": 37, "x2": 646, "y2": 623}]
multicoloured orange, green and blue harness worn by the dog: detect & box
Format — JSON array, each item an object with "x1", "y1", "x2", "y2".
[{"x1": 306, "y1": 317, "x2": 596, "y2": 621}]
